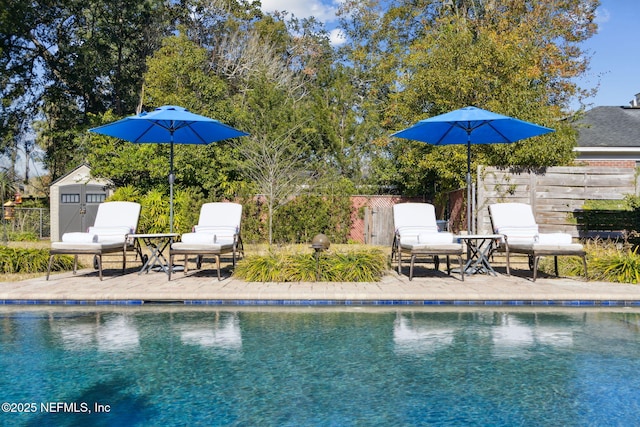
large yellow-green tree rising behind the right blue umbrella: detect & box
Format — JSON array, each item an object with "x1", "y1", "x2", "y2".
[{"x1": 344, "y1": 0, "x2": 598, "y2": 195}]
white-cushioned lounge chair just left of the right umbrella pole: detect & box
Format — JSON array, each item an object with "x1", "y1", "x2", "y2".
[{"x1": 391, "y1": 203, "x2": 464, "y2": 280}]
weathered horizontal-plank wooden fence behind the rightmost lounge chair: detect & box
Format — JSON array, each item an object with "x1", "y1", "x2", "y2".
[{"x1": 475, "y1": 166, "x2": 638, "y2": 237}]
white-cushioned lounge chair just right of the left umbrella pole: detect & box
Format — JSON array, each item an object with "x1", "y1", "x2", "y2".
[{"x1": 169, "y1": 202, "x2": 244, "y2": 280}]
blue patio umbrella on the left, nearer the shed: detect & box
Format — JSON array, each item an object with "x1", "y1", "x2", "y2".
[{"x1": 89, "y1": 105, "x2": 248, "y2": 233}]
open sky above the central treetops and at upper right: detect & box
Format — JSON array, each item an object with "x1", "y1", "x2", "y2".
[{"x1": 262, "y1": 0, "x2": 640, "y2": 109}]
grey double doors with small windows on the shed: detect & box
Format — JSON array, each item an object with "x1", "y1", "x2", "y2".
[{"x1": 59, "y1": 184, "x2": 107, "y2": 236}]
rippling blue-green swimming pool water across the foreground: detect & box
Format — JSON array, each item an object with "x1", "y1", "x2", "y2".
[{"x1": 0, "y1": 306, "x2": 640, "y2": 426}]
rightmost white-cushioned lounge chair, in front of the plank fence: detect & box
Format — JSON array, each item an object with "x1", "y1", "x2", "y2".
[{"x1": 489, "y1": 203, "x2": 587, "y2": 282}]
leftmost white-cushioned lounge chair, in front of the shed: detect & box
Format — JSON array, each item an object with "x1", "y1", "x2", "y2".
[{"x1": 47, "y1": 202, "x2": 140, "y2": 280}]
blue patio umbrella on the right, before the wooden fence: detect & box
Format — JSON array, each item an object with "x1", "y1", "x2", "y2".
[{"x1": 391, "y1": 107, "x2": 554, "y2": 233}]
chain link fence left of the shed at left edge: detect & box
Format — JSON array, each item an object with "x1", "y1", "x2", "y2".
[{"x1": 0, "y1": 206, "x2": 51, "y2": 239}]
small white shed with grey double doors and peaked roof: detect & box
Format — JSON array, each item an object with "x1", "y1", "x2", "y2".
[{"x1": 49, "y1": 164, "x2": 113, "y2": 242}]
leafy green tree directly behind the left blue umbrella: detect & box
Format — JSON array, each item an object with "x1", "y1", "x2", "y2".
[{"x1": 88, "y1": 33, "x2": 249, "y2": 202}]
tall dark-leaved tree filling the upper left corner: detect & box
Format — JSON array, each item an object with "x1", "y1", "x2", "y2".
[{"x1": 0, "y1": 0, "x2": 171, "y2": 179}]
